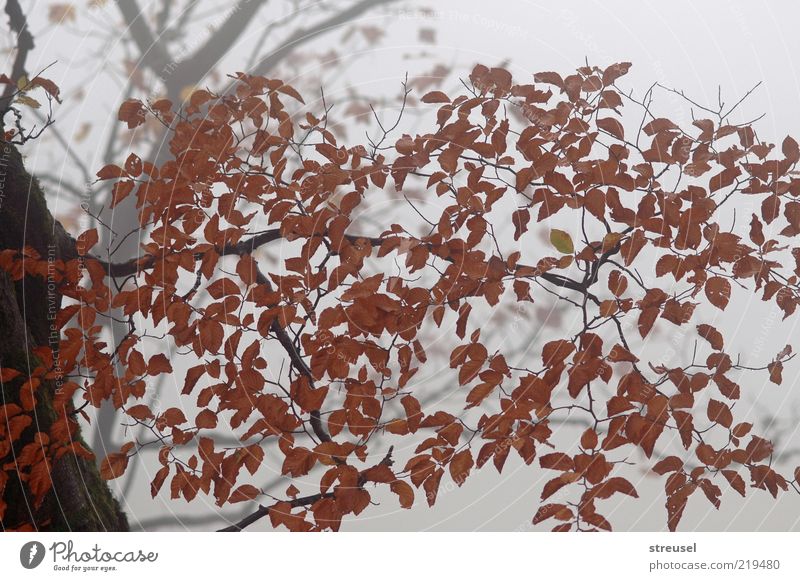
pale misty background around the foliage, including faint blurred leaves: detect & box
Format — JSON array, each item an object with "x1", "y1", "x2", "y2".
[{"x1": 9, "y1": 0, "x2": 800, "y2": 531}]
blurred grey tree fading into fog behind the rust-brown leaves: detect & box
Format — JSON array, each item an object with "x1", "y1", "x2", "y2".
[{"x1": 12, "y1": 0, "x2": 447, "y2": 468}]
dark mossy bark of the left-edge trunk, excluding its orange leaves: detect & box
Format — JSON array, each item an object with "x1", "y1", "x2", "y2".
[{"x1": 0, "y1": 141, "x2": 128, "y2": 531}]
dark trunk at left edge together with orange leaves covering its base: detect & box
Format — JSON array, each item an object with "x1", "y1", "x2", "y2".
[{"x1": 0, "y1": 142, "x2": 128, "y2": 531}]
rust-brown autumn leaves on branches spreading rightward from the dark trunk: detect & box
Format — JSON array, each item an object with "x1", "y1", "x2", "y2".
[{"x1": 0, "y1": 63, "x2": 800, "y2": 531}]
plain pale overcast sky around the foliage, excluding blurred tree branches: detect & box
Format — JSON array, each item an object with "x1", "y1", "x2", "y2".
[{"x1": 9, "y1": 0, "x2": 800, "y2": 531}]
